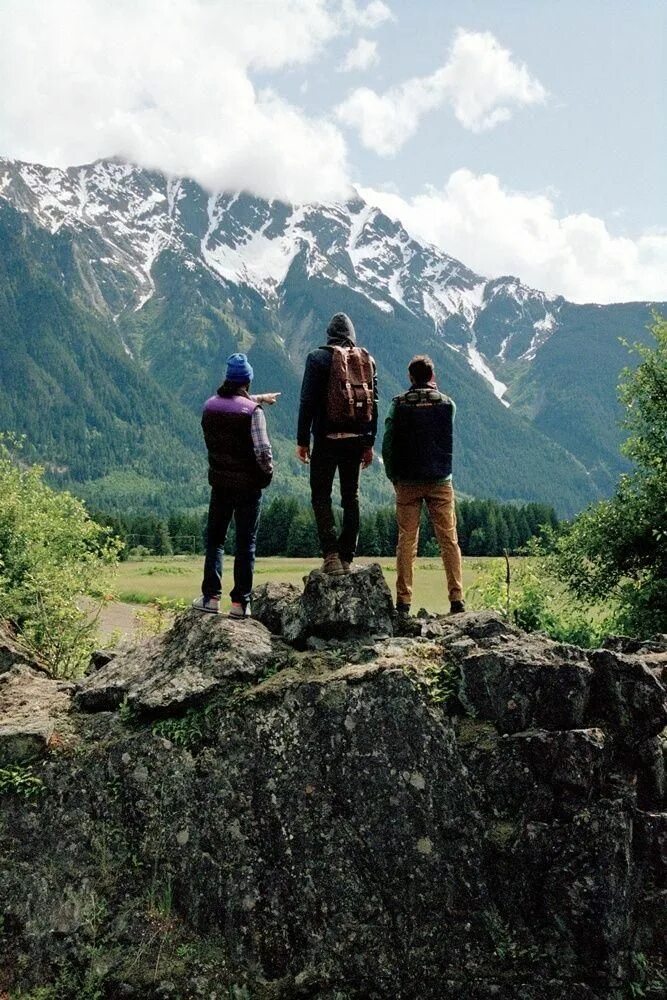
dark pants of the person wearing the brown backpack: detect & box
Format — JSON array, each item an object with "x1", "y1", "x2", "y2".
[{"x1": 310, "y1": 438, "x2": 366, "y2": 562}]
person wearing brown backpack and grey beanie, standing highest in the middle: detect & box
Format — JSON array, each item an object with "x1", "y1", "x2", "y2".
[{"x1": 296, "y1": 313, "x2": 377, "y2": 576}]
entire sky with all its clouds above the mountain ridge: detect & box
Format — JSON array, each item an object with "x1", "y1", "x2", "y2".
[{"x1": 0, "y1": 0, "x2": 667, "y2": 302}]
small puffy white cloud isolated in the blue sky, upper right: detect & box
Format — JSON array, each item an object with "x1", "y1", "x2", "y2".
[{"x1": 336, "y1": 30, "x2": 546, "y2": 156}]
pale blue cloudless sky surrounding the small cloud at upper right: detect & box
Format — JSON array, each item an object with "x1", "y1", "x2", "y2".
[{"x1": 316, "y1": 0, "x2": 667, "y2": 235}]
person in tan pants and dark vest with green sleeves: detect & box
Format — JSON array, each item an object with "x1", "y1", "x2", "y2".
[{"x1": 382, "y1": 354, "x2": 465, "y2": 616}]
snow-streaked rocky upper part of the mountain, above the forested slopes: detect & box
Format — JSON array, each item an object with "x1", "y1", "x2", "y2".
[{"x1": 0, "y1": 159, "x2": 558, "y2": 398}]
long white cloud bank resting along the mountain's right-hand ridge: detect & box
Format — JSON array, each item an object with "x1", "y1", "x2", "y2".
[{"x1": 359, "y1": 170, "x2": 667, "y2": 303}]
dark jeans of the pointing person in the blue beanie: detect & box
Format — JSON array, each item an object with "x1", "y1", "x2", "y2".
[{"x1": 201, "y1": 488, "x2": 262, "y2": 608}]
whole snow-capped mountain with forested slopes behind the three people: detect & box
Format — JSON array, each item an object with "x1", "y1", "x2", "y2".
[{"x1": 0, "y1": 160, "x2": 664, "y2": 513}]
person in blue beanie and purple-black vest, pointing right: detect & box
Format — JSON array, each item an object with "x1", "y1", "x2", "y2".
[{"x1": 192, "y1": 354, "x2": 280, "y2": 618}]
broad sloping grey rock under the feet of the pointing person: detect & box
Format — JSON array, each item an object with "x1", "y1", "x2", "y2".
[{"x1": 75, "y1": 610, "x2": 276, "y2": 715}]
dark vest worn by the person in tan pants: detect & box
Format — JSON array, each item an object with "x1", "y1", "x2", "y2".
[{"x1": 392, "y1": 386, "x2": 454, "y2": 483}]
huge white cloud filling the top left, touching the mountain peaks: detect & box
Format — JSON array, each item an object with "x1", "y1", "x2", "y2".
[{"x1": 0, "y1": 0, "x2": 391, "y2": 200}]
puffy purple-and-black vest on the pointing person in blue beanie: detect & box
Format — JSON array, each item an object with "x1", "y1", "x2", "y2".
[{"x1": 201, "y1": 390, "x2": 272, "y2": 491}]
